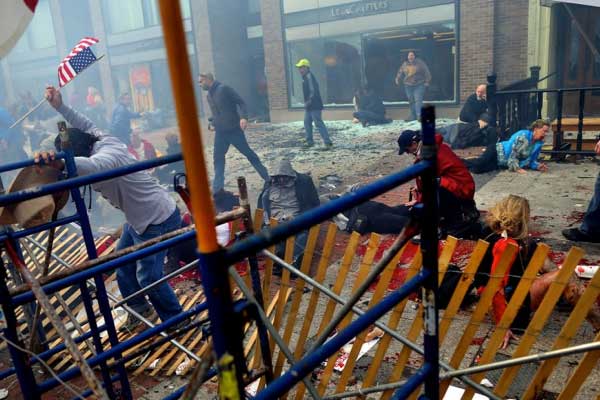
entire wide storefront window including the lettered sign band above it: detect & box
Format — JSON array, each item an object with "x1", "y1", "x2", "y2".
[{"x1": 284, "y1": 0, "x2": 457, "y2": 107}]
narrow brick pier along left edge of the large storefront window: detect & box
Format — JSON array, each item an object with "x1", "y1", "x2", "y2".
[{"x1": 261, "y1": 0, "x2": 288, "y2": 110}]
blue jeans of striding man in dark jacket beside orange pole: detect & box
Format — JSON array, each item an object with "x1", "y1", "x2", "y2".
[{"x1": 213, "y1": 128, "x2": 269, "y2": 193}]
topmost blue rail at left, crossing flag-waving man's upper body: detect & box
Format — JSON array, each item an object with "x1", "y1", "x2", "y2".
[{"x1": 0, "y1": 154, "x2": 183, "y2": 207}]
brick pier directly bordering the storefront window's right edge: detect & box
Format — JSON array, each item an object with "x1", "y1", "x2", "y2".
[{"x1": 458, "y1": 0, "x2": 494, "y2": 102}]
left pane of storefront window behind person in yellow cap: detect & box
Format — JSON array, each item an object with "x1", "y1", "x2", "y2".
[{"x1": 288, "y1": 35, "x2": 362, "y2": 107}]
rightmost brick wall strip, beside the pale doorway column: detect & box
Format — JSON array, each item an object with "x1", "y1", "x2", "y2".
[{"x1": 494, "y1": 0, "x2": 529, "y2": 88}]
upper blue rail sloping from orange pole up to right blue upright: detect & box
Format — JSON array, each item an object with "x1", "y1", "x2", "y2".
[{"x1": 224, "y1": 161, "x2": 432, "y2": 265}]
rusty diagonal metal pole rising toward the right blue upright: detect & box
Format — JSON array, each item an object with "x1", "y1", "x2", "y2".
[{"x1": 308, "y1": 217, "x2": 420, "y2": 353}]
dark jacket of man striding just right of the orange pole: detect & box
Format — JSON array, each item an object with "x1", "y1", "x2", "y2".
[{"x1": 207, "y1": 81, "x2": 248, "y2": 132}]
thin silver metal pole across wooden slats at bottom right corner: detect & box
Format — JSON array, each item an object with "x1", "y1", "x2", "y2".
[{"x1": 440, "y1": 342, "x2": 600, "y2": 380}]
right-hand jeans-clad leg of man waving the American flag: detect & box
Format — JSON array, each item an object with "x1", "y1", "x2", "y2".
[{"x1": 132, "y1": 209, "x2": 182, "y2": 321}]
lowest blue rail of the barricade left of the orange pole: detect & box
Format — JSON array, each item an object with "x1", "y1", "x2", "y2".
[{"x1": 38, "y1": 303, "x2": 207, "y2": 393}]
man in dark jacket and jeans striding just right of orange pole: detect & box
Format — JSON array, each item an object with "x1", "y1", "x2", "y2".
[{"x1": 198, "y1": 73, "x2": 269, "y2": 193}]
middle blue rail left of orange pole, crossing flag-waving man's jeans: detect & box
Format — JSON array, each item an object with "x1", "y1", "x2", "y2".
[{"x1": 12, "y1": 231, "x2": 196, "y2": 307}]
